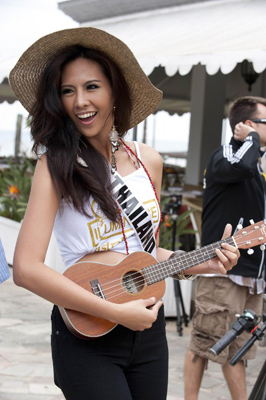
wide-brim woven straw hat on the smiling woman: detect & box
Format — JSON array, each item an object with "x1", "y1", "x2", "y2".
[{"x1": 9, "y1": 27, "x2": 162, "y2": 129}]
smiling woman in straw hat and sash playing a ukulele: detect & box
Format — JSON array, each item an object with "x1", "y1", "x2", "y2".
[{"x1": 10, "y1": 28, "x2": 239, "y2": 400}]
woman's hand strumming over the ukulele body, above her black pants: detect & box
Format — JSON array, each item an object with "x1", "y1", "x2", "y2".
[{"x1": 112, "y1": 297, "x2": 163, "y2": 331}]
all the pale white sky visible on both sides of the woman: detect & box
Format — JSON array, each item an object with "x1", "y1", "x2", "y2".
[{"x1": 0, "y1": 0, "x2": 230, "y2": 162}]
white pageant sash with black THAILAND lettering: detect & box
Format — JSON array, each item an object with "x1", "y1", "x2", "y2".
[{"x1": 111, "y1": 172, "x2": 156, "y2": 253}]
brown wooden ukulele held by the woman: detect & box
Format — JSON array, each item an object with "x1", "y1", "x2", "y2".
[{"x1": 59, "y1": 221, "x2": 266, "y2": 339}]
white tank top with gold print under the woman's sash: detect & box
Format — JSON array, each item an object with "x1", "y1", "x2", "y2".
[{"x1": 54, "y1": 142, "x2": 160, "y2": 273}]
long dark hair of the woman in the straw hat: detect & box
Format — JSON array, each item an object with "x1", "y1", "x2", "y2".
[{"x1": 31, "y1": 45, "x2": 132, "y2": 221}]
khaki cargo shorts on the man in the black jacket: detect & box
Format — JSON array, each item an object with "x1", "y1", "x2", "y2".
[{"x1": 189, "y1": 276, "x2": 263, "y2": 364}]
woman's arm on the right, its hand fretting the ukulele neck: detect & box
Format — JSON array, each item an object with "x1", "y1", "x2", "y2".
[{"x1": 140, "y1": 144, "x2": 240, "y2": 275}]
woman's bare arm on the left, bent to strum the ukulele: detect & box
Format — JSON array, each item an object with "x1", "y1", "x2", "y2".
[{"x1": 13, "y1": 156, "x2": 162, "y2": 330}]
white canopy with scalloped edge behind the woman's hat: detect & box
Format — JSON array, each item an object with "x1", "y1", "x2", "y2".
[{"x1": 81, "y1": 0, "x2": 266, "y2": 76}]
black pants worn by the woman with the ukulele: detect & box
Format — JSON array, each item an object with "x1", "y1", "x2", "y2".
[{"x1": 52, "y1": 306, "x2": 168, "y2": 400}]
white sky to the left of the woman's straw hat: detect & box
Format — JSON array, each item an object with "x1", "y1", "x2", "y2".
[{"x1": 0, "y1": 0, "x2": 78, "y2": 156}]
